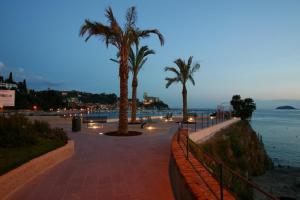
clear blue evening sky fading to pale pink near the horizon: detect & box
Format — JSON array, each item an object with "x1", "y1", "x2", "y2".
[{"x1": 0, "y1": 0, "x2": 300, "y2": 108}]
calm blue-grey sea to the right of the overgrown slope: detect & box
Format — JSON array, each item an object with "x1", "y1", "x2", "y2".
[{"x1": 251, "y1": 110, "x2": 300, "y2": 167}]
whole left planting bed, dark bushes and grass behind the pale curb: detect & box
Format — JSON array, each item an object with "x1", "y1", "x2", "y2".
[{"x1": 0, "y1": 115, "x2": 68, "y2": 175}]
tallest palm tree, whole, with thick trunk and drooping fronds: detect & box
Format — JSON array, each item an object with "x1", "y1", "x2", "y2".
[{"x1": 79, "y1": 7, "x2": 164, "y2": 134}]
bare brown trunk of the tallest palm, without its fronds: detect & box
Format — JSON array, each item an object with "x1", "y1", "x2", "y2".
[{"x1": 118, "y1": 51, "x2": 129, "y2": 134}]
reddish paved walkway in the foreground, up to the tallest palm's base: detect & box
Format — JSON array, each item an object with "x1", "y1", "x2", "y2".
[{"x1": 10, "y1": 118, "x2": 175, "y2": 200}]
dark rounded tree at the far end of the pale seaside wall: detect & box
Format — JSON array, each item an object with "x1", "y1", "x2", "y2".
[{"x1": 230, "y1": 95, "x2": 256, "y2": 120}]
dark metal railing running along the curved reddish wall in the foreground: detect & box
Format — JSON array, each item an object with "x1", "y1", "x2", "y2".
[{"x1": 177, "y1": 121, "x2": 278, "y2": 200}]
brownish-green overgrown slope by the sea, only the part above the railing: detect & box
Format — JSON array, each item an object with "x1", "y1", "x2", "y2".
[{"x1": 200, "y1": 121, "x2": 273, "y2": 176}]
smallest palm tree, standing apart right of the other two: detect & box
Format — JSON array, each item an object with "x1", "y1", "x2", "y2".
[{"x1": 165, "y1": 56, "x2": 200, "y2": 122}]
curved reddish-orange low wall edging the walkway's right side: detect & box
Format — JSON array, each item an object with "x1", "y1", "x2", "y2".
[{"x1": 169, "y1": 129, "x2": 235, "y2": 200}]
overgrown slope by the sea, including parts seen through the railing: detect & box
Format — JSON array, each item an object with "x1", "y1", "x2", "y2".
[{"x1": 190, "y1": 121, "x2": 273, "y2": 199}]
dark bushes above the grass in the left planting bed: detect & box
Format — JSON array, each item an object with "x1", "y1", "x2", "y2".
[{"x1": 0, "y1": 115, "x2": 68, "y2": 148}]
